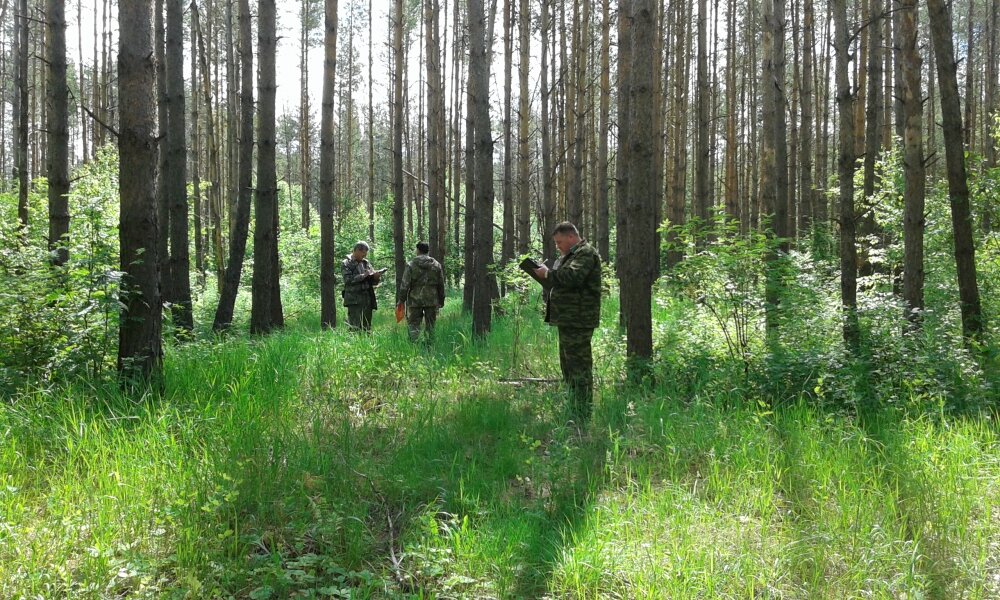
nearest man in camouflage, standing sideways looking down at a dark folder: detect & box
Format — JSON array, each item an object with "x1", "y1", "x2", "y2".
[{"x1": 535, "y1": 221, "x2": 601, "y2": 421}]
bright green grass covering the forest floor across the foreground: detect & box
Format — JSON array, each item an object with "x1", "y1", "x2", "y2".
[{"x1": 0, "y1": 302, "x2": 1000, "y2": 599}]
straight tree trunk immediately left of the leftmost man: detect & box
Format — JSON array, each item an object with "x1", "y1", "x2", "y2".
[{"x1": 319, "y1": 0, "x2": 337, "y2": 328}]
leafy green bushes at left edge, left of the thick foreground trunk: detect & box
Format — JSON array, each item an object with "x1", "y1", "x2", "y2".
[{"x1": 0, "y1": 148, "x2": 120, "y2": 395}]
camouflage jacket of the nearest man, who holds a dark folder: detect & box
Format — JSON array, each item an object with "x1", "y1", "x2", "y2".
[{"x1": 545, "y1": 241, "x2": 601, "y2": 329}]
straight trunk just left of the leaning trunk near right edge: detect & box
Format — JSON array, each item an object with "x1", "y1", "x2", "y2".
[{"x1": 894, "y1": 0, "x2": 926, "y2": 326}]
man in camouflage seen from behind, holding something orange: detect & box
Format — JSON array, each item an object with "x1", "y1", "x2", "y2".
[{"x1": 396, "y1": 242, "x2": 444, "y2": 342}]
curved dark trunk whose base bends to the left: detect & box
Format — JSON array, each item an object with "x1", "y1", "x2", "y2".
[{"x1": 212, "y1": 0, "x2": 254, "y2": 331}]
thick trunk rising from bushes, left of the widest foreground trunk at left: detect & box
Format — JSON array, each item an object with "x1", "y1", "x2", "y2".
[{"x1": 45, "y1": 0, "x2": 69, "y2": 265}]
